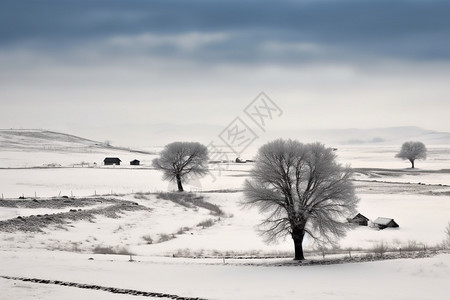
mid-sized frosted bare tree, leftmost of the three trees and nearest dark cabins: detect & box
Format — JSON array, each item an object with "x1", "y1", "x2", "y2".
[{"x1": 152, "y1": 142, "x2": 208, "y2": 192}]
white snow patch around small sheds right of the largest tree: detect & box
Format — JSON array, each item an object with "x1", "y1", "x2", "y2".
[{"x1": 341, "y1": 194, "x2": 450, "y2": 248}]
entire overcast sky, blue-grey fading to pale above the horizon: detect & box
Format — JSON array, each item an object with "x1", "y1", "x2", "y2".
[{"x1": 0, "y1": 0, "x2": 450, "y2": 145}]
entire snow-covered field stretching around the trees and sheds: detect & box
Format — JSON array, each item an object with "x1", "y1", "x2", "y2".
[{"x1": 0, "y1": 134, "x2": 450, "y2": 299}]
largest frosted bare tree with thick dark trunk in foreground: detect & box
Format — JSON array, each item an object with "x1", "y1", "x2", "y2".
[{"x1": 244, "y1": 139, "x2": 359, "y2": 260}]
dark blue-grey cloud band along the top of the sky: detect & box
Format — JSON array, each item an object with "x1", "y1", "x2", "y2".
[{"x1": 0, "y1": 0, "x2": 450, "y2": 63}]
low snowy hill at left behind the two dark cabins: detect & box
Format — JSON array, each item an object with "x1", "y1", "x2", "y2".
[{"x1": 0, "y1": 129, "x2": 156, "y2": 168}]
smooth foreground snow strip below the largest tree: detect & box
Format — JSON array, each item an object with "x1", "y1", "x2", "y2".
[{"x1": 0, "y1": 251, "x2": 450, "y2": 300}]
